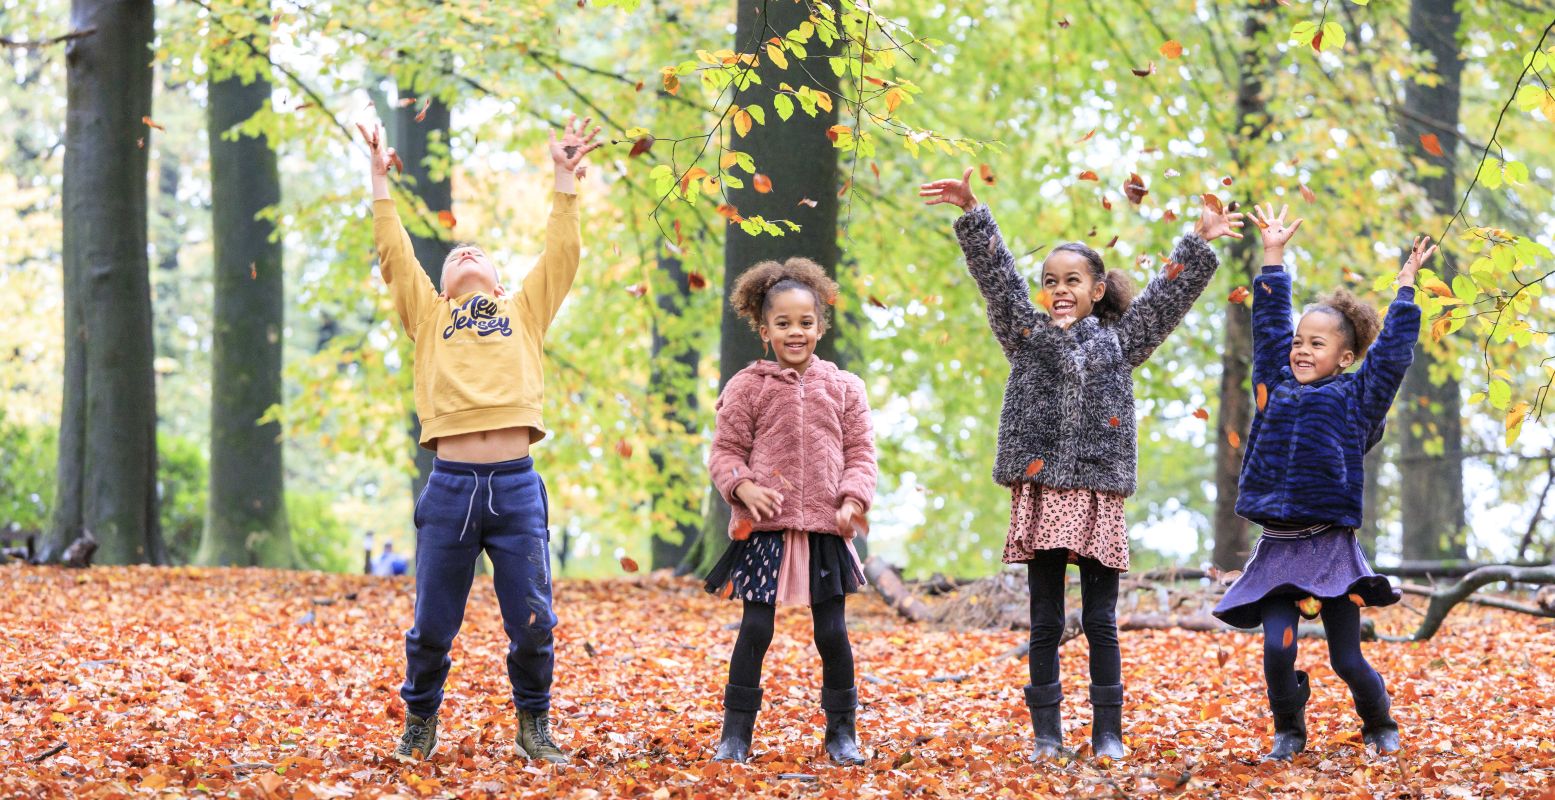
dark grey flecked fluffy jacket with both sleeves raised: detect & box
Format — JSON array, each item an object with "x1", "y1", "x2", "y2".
[{"x1": 955, "y1": 205, "x2": 1219, "y2": 496}]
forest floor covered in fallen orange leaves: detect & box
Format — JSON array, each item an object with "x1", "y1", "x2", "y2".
[{"x1": 0, "y1": 567, "x2": 1555, "y2": 798}]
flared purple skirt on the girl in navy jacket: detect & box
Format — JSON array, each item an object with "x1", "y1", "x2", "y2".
[{"x1": 1213, "y1": 528, "x2": 1401, "y2": 627}]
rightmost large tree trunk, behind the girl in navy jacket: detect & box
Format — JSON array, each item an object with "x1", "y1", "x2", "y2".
[{"x1": 1396, "y1": 0, "x2": 1468, "y2": 559}]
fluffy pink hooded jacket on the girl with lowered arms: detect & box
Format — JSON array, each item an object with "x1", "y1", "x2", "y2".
[{"x1": 708, "y1": 355, "x2": 875, "y2": 537}]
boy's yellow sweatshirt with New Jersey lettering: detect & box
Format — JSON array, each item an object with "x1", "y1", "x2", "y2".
[{"x1": 373, "y1": 191, "x2": 580, "y2": 450}]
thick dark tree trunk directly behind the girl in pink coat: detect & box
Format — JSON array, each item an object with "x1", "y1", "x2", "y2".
[{"x1": 692, "y1": 2, "x2": 843, "y2": 567}]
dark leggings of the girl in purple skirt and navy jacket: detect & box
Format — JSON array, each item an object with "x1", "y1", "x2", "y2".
[{"x1": 1258, "y1": 596, "x2": 1387, "y2": 705}]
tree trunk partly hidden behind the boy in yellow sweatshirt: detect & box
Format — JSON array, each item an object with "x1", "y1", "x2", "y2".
[{"x1": 390, "y1": 94, "x2": 454, "y2": 498}]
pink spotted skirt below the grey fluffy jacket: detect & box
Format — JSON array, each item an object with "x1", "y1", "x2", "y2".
[{"x1": 1005, "y1": 482, "x2": 1129, "y2": 573}]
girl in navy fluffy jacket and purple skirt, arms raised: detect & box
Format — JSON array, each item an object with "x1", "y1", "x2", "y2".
[{"x1": 1214, "y1": 205, "x2": 1437, "y2": 761}]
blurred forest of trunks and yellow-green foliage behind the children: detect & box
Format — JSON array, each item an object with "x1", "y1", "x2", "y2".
[{"x1": 0, "y1": 0, "x2": 1555, "y2": 576}]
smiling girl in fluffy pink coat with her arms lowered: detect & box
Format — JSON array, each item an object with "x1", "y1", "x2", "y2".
[{"x1": 708, "y1": 258, "x2": 875, "y2": 764}]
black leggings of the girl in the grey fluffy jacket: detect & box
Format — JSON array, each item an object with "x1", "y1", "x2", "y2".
[{"x1": 1026, "y1": 549, "x2": 1123, "y2": 686}]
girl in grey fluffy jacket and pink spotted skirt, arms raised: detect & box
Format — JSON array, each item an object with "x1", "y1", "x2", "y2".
[{"x1": 919, "y1": 170, "x2": 1242, "y2": 758}]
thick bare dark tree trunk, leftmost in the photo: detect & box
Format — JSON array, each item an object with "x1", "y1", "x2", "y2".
[{"x1": 40, "y1": 0, "x2": 166, "y2": 563}]
